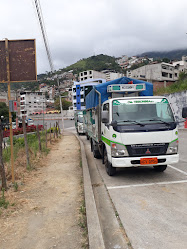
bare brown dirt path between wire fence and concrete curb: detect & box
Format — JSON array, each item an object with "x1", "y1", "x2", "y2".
[{"x1": 0, "y1": 134, "x2": 83, "y2": 249}]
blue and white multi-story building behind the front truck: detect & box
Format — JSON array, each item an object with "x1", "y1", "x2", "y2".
[{"x1": 72, "y1": 78, "x2": 106, "y2": 110}]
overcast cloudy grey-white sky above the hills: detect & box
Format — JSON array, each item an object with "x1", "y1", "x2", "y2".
[{"x1": 0, "y1": 0, "x2": 187, "y2": 74}]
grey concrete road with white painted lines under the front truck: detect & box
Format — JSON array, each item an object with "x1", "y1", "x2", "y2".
[{"x1": 81, "y1": 131, "x2": 187, "y2": 249}]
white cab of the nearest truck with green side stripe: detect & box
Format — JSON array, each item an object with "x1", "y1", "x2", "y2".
[{"x1": 101, "y1": 96, "x2": 179, "y2": 175}]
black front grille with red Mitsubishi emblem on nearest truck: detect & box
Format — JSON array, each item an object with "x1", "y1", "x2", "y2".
[{"x1": 126, "y1": 143, "x2": 168, "y2": 157}]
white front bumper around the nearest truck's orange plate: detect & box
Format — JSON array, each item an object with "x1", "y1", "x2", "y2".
[{"x1": 111, "y1": 154, "x2": 179, "y2": 167}]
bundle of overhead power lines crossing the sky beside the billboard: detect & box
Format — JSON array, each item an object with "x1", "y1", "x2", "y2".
[{"x1": 34, "y1": 0, "x2": 54, "y2": 72}]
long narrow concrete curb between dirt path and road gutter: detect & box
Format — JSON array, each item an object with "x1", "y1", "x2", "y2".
[{"x1": 75, "y1": 134, "x2": 105, "y2": 249}]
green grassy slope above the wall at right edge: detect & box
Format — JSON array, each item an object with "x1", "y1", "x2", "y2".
[{"x1": 154, "y1": 72, "x2": 187, "y2": 95}]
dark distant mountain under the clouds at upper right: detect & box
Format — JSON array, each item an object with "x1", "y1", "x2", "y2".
[{"x1": 138, "y1": 49, "x2": 187, "y2": 60}]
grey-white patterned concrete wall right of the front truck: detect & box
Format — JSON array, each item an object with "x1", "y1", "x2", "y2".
[{"x1": 165, "y1": 91, "x2": 187, "y2": 128}]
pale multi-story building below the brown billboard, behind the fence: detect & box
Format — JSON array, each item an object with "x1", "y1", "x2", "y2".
[{"x1": 20, "y1": 91, "x2": 46, "y2": 118}]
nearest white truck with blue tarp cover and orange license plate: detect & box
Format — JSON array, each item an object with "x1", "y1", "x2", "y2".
[{"x1": 84, "y1": 77, "x2": 186, "y2": 176}]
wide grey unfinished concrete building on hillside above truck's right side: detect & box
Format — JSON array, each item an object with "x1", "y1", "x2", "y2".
[{"x1": 127, "y1": 62, "x2": 179, "y2": 81}]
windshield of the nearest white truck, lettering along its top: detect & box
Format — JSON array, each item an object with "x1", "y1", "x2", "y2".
[{"x1": 113, "y1": 98, "x2": 175, "y2": 124}]
